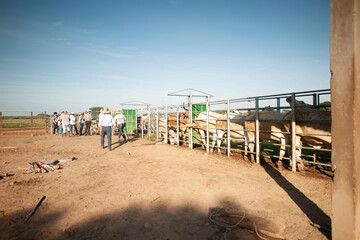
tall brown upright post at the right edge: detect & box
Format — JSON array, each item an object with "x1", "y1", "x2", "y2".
[{"x1": 330, "y1": 0, "x2": 360, "y2": 240}]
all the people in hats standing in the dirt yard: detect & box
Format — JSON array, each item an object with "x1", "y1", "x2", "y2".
[{"x1": 52, "y1": 108, "x2": 127, "y2": 151}]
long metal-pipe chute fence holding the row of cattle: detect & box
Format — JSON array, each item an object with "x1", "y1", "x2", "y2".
[{"x1": 138, "y1": 89, "x2": 332, "y2": 171}]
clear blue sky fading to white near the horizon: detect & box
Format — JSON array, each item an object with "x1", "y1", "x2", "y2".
[{"x1": 0, "y1": 0, "x2": 330, "y2": 112}]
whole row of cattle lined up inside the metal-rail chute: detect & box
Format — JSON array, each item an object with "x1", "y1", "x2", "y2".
[{"x1": 141, "y1": 94, "x2": 331, "y2": 171}]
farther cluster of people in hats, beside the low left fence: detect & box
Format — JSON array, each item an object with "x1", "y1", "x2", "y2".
[{"x1": 52, "y1": 110, "x2": 92, "y2": 136}]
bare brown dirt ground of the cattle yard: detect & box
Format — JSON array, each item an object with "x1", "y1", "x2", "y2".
[{"x1": 0, "y1": 135, "x2": 331, "y2": 240}]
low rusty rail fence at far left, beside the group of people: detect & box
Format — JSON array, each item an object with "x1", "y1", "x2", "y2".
[{"x1": 0, "y1": 111, "x2": 51, "y2": 135}]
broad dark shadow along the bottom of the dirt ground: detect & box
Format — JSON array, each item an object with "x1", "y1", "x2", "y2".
[{"x1": 0, "y1": 200, "x2": 277, "y2": 240}]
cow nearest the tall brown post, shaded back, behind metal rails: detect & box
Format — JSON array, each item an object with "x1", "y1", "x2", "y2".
[{"x1": 283, "y1": 98, "x2": 331, "y2": 170}]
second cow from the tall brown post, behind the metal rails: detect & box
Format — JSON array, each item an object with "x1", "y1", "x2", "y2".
[{"x1": 244, "y1": 111, "x2": 288, "y2": 167}]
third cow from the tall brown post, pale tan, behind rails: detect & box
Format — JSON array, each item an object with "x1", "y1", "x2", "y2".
[{"x1": 216, "y1": 112, "x2": 248, "y2": 155}]
